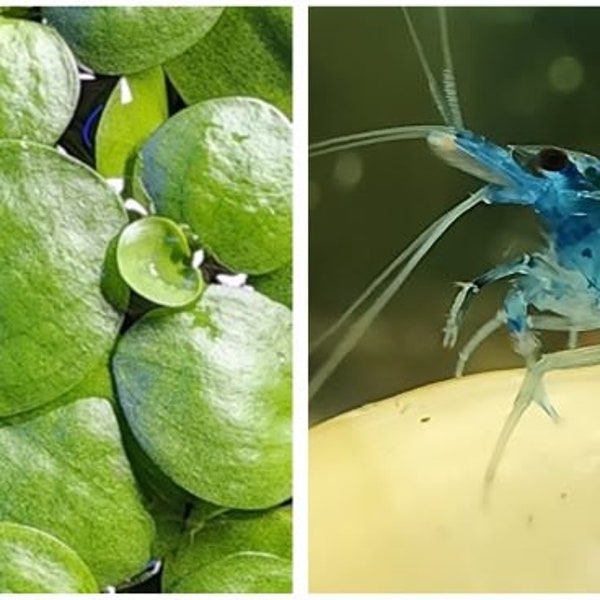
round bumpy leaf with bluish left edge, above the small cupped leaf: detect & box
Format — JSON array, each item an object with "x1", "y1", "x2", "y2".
[{"x1": 137, "y1": 97, "x2": 292, "y2": 273}]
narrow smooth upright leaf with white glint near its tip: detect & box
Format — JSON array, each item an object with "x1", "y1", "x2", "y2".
[{"x1": 96, "y1": 67, "x2": 169, "y2": 178}]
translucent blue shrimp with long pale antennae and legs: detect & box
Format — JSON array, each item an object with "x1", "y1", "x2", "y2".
[{"x1": 310, "y1": 8, "x2": 600, "y2": 493}]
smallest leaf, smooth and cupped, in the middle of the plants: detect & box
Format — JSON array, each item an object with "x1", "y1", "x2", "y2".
[{"x1": 117, "y1": 217, "x2": 204, "y2": 307}]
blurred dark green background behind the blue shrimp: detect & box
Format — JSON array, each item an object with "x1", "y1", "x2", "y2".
[{"x1": 309, "y1": 7, "x2": 600, "y2": 423}]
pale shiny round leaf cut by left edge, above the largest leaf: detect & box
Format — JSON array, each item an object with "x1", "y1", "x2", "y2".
[{"x1": 0, "y1": 18, "x2": 79, "y2": 144}]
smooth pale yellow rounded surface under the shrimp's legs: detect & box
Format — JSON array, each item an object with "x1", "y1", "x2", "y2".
[{"x1": 309, "y1": 367, "x2": 600, "y2": 592}]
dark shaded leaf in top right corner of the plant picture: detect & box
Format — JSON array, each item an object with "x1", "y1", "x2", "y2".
[{"x1": 165, "y1": 6, "x2": 292, "y2": 116}]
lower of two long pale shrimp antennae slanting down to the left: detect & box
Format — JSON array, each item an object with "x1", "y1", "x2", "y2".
[{"x1": 308, "y1": 186, "x2": 488, "y2": 399}]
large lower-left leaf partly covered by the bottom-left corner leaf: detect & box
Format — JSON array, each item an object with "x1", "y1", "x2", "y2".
[{"x1": 0, "y1": 398, "x2": 154, "y2": 587}]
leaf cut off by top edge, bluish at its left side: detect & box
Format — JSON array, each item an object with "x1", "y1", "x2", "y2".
[{"x1": 43, "y1": 6, "x2": 223, "y2": 74}]
